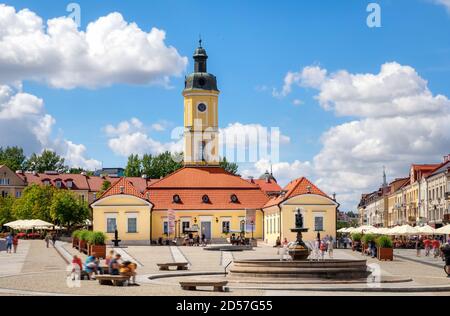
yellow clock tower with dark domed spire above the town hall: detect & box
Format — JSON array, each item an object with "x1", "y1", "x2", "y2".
[{"x1": 183, "y1": 40, "x2": 220, "y2": 166}]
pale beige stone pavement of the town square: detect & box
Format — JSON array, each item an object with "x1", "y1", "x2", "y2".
[{"x1": 0, "y1": 240, "x2": 450, "y2": 296}]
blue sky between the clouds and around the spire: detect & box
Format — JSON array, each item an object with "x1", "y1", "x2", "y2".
[{"x1": 0, "y1": 0, "x2": 450, "y2": 208}]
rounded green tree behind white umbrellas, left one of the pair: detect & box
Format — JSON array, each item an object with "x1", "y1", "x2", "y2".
[{"x1": 13, "y1": 184, "x2": 55, "y2": 222}]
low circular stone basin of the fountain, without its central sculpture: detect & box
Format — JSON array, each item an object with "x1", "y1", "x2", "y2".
[{"x1": 229, "y1": 259, "x2": 371, "y2": 280}]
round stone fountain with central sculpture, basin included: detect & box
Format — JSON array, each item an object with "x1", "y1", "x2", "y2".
[{"x1": 228, "y1": 210, "x2": 370, "y2": 283}]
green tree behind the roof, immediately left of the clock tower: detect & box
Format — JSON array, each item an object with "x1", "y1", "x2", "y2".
[{"x1": 142, "y1": 151, "x2": 183, "y2": 179}]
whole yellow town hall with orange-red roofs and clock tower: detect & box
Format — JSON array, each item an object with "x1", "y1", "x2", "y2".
[{"x1": 91, "y1": 42, "x2": 339, "y2": 244}]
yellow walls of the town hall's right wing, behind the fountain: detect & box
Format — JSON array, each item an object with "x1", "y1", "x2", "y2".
[{"x1": 264, "y1": 194, "x2": 337, "y2": 244}]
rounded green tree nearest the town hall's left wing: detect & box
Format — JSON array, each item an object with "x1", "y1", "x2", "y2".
[{"x1": 50, "y1": 190, "x2": 90, "y2": 230}]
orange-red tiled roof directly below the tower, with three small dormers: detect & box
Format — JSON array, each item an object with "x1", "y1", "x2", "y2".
[{"x1": 147, "y1": 167, "x2": 268, "y2": 210}]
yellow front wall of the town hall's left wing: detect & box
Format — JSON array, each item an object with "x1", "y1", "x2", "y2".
[{"x1": 92, "y1": 195, "x2": 151, "y2": 241}]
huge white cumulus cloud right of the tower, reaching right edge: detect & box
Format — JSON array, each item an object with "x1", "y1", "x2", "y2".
[{"x1": 258, "y1": 62, "x2": 450, "y2": 209}]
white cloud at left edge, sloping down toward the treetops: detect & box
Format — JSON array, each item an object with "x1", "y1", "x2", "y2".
[{"x1": 0, "y1": 86, "x2": 100, "y2": 170}]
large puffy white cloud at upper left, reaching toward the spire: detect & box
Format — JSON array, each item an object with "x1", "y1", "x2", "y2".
[{"x1": 0, "y1": 4, "x2": 187, "y2": 89}]
